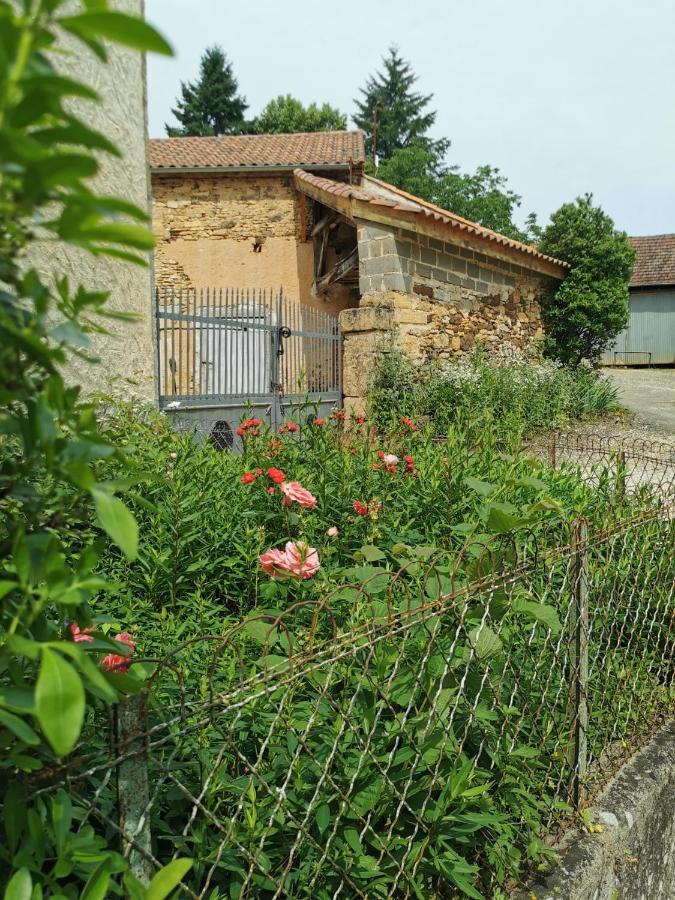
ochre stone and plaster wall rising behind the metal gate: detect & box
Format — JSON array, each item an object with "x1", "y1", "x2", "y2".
[{"x1": 152, "y1": 173, "x2": 353, "y2": 312}]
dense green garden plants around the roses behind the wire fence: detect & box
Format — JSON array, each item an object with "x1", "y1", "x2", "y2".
[{"x1": 73, "y1": 404, "x2": 671, "y2": 897}]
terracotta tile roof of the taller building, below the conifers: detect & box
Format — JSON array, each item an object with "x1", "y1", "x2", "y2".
[{"x1": 150, "y1": 131, "x2": 365, "y2": 169}]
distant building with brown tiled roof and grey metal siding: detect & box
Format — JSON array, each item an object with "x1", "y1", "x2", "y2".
[{"x1": 603, "y1": 234, "x2": 675, "y2": 366}]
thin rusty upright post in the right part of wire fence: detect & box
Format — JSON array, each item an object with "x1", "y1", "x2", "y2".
[{"x1": 569, "y1": 519, "x2": 589, "y2": 810}]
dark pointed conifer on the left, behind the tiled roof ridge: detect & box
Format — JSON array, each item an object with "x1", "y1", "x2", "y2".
[{"x1": 164, "y1": 46, "x2": 248, "y2": 137}]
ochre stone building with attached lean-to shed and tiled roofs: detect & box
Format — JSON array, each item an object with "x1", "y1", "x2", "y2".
[{"x1": 151, "y1": 132, "x2": 567, "y2": 407}]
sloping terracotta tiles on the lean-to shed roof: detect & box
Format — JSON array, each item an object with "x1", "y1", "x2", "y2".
[{"x1": 293, "y1": 169, "x2": 570, "y2": 278}]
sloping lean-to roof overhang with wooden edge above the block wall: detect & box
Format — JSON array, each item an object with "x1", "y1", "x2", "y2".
[{"x1": 294, "y1": 169, "x2": 570, "y2": 281}]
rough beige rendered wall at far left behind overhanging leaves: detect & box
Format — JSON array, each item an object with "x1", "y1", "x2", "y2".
[{"x1": 29, "y1": 0, "x2": 155, "y2": 400}]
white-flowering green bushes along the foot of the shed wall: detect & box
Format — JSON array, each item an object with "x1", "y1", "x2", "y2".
[{"x1": 370, "y1": 351, "x2": 618, "y2": 437}]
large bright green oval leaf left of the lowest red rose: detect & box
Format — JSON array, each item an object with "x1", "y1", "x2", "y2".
[{"x1": 35, "y1": 647, "x2": 85, "y2": 756}]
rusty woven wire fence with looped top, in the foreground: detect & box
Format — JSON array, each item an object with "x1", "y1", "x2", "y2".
[{"x1": 37, "y1": 503, "x2": 675, "y2": 900}]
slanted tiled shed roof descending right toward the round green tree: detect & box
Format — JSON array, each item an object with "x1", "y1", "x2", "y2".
[{"x1": 294, "y1": 169, "x2": 570, "y2": 280}]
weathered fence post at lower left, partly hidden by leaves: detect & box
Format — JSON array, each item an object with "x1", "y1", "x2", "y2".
[{"x1": 115, "y1": 693, "x2": 154, "y2": 885}]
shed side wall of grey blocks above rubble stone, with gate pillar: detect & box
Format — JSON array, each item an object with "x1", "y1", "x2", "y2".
[{"x1": 340, "y1": 223, "x2": 557, "y2": 409}]
